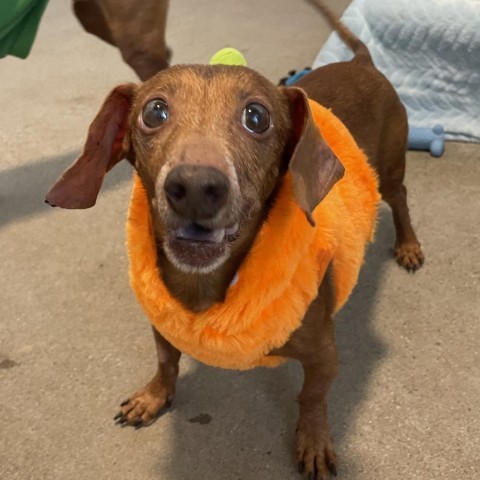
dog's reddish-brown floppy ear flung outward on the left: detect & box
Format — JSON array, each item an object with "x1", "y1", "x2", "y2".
[{"x1": 45, "y1": 84, "x2": 135, "y2": 208}]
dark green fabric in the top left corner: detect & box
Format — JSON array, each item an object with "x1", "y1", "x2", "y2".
[{"x1": 0, "y1": 0, "x2": 48, "y2": 58}]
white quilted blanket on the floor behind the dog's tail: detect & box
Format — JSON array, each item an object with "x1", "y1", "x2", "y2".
[{"x1": 313, "y1": 0, "x2": 480, "y2": 142}]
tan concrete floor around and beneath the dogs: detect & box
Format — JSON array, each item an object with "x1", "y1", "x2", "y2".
[{"x1": 0, "y1": 0, "x2": 480, "y2": 480}]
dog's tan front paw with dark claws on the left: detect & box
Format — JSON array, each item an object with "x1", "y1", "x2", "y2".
[{"x1": 113, "y1": 379, "x2": 173, "y2": 428}]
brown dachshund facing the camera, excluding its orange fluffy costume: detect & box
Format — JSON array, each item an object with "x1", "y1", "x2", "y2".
[{"x1": 46, "y1": 4, "x2": 423, "y2": 480}]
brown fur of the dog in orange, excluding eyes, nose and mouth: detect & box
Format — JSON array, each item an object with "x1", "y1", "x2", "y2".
[{"x1": 47, "y1": 4, "x2": 423, "y2": 480}]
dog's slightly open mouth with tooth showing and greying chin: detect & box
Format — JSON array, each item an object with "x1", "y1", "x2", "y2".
[{"x1": 166, "y1": 223, "x2": 239, "y2": 272}]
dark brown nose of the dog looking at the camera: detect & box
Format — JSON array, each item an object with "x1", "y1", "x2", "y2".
[{"x1": 164, "y1": 165, "x2": 230, "y2": 221}]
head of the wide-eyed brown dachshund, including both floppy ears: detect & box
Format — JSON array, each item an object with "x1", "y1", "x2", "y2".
[{"x1": 46, "y1": 65, "x2": 343, "y2": 273}]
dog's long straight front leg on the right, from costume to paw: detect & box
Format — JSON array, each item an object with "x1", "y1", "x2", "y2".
[{"x1": 272, "y1": 272, "x2": 338, "y2": 480}]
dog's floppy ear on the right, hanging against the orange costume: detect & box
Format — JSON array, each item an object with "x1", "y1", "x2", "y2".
[{"x1": 285, "y1": 87, "x2": 345, "y2": 225}]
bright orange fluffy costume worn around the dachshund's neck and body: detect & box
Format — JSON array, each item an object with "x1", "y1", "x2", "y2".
[{"x1": 127, "y1": 102, "x2": 379, "y2": 370}]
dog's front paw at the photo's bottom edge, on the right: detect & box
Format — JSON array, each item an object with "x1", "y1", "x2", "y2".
[{"x1": 297, "y1": 420, "x2": 337, "y2": 480}]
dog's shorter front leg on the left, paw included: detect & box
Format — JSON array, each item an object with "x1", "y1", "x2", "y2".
[{"x1": 114, "y1": 328, "x2": 180, "y2": 427}]
